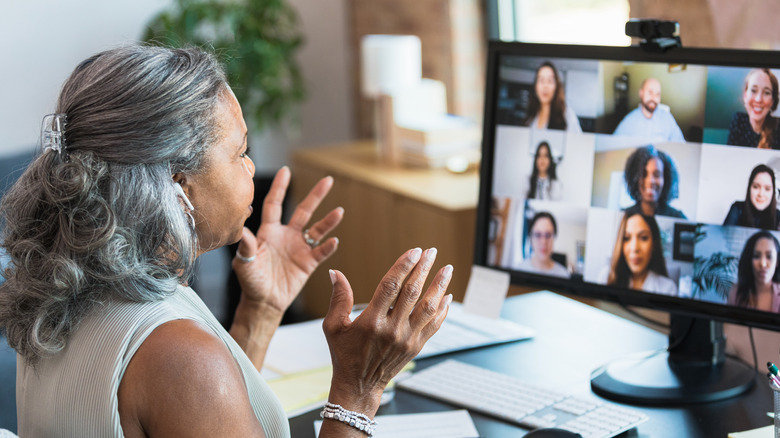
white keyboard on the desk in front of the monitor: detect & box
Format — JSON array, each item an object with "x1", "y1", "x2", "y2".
[{"x1": 397, "y1": 360, "x2": 647, "y2": 438}]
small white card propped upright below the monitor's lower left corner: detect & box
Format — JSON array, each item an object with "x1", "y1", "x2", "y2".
[{"x1": 463, "y1": 265, "x2": 510, "y2": 318}]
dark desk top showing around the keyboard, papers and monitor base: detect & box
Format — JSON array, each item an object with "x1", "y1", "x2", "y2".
[{"x1": 291, "y1": 292, "x2": 772, "y2": 438}]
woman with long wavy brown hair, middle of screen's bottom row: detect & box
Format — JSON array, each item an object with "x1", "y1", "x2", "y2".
[{"x1": 599, "y1": 212, "x2": 677, "y2": 295}]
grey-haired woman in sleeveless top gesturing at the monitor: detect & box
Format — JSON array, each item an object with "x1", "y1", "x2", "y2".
[{"x1": 0, "y1": 46, "x2": 451, "y2": 437}]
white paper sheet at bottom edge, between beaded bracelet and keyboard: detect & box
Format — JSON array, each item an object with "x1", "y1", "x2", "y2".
[{"x1": 314, "y1": 409, "x2": 479, "y2": 438}]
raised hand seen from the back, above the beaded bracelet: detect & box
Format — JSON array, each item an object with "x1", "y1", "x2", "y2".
[{"x1": 323, "y1": 248, "x2": 452, "y2": 418}]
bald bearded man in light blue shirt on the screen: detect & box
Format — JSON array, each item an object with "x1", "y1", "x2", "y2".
[{"x1": 614, "y1": 78, "x2": 685, "y2": 142}]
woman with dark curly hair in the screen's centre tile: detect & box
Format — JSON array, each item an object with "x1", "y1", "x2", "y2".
[{"x1": 623, "y1": 145, "x2": 685, "y2": 219}]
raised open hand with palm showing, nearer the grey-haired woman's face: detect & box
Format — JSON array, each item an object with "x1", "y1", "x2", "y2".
[{"x1": 233, "y1": 166, "x2": 344, "y2": 313}]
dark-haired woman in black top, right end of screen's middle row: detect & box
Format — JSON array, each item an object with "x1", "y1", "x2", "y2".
[{"x1": 723, "y1": 164, "x2": 780, "y2": 230}]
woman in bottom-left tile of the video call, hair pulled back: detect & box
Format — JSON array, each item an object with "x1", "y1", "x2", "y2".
[{"x1": 518, "y1": 211, "x2": 569, "y2": 277}]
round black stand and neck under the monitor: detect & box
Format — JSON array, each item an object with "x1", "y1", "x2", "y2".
[{"x1": 591, "y1": 314, "x2": 756, "y2": 405}]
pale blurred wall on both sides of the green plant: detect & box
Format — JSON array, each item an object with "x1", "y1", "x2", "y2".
[{"x1": 0, "y1": 0, "x2": 354, "y2": 173}]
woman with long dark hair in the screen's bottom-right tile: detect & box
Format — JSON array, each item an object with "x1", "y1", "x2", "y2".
[{"x1": 728, "y1": 230, "x2": 780, "y2": 313}]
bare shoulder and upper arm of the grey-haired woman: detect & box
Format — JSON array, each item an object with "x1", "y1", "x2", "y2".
[{"x1": 118, "y1": 319, "x2": 260, "y2": 436}]
